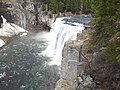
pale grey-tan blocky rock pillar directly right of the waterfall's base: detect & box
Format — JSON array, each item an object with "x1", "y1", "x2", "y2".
[{"x1": 55, "y1": 33, "x2": 87, "y2": 90}]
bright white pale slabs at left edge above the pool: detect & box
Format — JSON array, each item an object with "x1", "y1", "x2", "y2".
[{"x1": 0, "y1": 15, "x2": 27, "y2": 47}]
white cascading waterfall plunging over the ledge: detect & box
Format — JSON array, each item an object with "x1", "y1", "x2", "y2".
[{"x1": 42, "y1": 17, "x2": 84, "y2": 65}]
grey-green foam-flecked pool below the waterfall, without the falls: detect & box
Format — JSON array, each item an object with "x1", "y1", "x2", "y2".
[{"x1": 0, "y1": 32, "x2": 59, "y2": 90}]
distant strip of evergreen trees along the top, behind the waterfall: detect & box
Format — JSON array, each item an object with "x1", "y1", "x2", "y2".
[{"x1": 40, "y1": 0, "x2": 91, "y2": 13}]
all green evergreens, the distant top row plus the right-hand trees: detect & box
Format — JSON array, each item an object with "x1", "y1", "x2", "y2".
[{"x1": 38, "y1": 0, "x2": 120, "y2": 61}]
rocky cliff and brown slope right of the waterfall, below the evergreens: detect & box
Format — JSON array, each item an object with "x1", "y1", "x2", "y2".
[{"x1": 55, "y1": 29, "x2": 120, "y2": 90}]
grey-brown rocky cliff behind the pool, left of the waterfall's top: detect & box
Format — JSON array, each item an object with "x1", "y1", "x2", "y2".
[{"x1": 0, "y1": 0, "x2": 53, "y2": 31}]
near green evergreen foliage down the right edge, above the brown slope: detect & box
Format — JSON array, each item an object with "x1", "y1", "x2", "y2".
[{"x1": 92, "y1": 0, "x2": 120, "y2": 62}]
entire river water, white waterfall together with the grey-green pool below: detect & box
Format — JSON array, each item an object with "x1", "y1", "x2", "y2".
[{"x1": 0, "y1": 17, "x2": 91, "y2": 90}]
